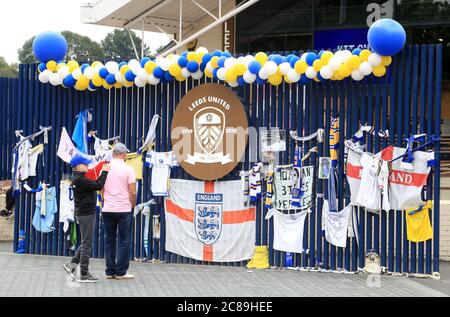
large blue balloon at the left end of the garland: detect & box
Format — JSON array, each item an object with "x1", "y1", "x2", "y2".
[{"x1": 33, "y1": 32, "x2": 67, "y2": 63}]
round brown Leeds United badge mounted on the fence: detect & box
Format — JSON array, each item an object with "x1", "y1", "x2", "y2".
[{"x1": 171, "y1": 84, "x2": 248, "y2": 180}]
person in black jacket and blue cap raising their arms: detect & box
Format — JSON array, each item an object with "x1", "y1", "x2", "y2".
[{"x1": 64, "y1": 155, "x2": 110, "y2": 283}]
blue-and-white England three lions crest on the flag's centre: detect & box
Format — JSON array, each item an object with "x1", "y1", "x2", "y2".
[{"x1": 194, "y1": 194, "x2": 223, "y2": 245}]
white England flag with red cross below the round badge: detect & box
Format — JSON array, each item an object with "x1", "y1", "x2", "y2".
[{"x1": 164, "y1": 179, "x2": 256, "y2": 262}]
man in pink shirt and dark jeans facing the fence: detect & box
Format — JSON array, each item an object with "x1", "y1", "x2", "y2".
[{"x1": 102, "y1": 143, "x2": 136, "y2": 279}]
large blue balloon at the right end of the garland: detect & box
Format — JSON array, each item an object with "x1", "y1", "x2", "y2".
[{"x1": 367, "y1": 19, "x2": 406, "y2": 56}]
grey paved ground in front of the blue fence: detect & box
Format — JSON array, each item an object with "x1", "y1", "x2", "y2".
[{"x1": 0, "y1": 242, "x2": 450, "y2": 298}]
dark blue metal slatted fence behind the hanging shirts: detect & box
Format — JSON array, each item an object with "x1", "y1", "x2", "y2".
[{"x1": 0, "y1": 45, "x2": 442, "y2": 274}]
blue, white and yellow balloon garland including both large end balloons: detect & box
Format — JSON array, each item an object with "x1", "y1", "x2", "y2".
[{"x1": 33, "y1": 19, "x2": 406, "y2": 91}]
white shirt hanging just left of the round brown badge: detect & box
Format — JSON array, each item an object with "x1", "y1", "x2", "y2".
[{"x1": 145, "y1": 151, "x2": 178, "y2": 196}]
